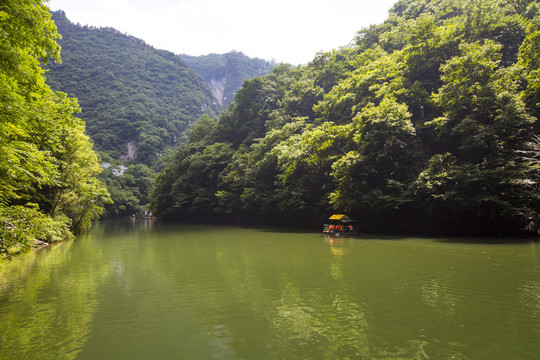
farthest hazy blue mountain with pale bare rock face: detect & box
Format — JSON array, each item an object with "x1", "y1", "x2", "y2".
[{"x1": 180, "y1": 51, "x2": 275, "y2": 108}]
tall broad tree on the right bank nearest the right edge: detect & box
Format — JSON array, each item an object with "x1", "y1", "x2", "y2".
[{"x1": 415, "y1": 40, "x2": 538, "y2": 234}]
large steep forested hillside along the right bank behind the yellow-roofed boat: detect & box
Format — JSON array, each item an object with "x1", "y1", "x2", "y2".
[{"x1": 152, "y1": 0, "x2": 540, "y2": 235}]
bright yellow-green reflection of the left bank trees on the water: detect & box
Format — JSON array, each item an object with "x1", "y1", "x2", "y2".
[{"x1": 0, "y1": 240, "x2": 108, "y2": 360}]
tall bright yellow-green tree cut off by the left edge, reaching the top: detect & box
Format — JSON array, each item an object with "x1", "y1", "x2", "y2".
[{"x1": 0, "y1": 0, "x2": 60, "y2": 204}]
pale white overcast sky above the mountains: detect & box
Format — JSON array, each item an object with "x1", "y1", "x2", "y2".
[{"x1": 48, "y1": 0, "x2": 397, "y2": 65}]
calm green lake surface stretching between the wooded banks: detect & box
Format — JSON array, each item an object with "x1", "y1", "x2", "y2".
[{"x1": 0, "y1": 221, "x2": 540, "y2": 360}]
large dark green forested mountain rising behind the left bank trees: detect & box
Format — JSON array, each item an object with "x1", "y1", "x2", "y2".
[{"x1": 46, "y1": 11, "x2": 219, "y2": 165}]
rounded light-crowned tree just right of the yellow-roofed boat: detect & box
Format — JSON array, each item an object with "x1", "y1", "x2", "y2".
[{"x1": 330, "y1": 97, "x2": 419, "y2": 231}]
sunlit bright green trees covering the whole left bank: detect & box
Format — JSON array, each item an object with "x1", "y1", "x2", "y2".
[{"x1": 0, "y1": 0, "x2": 109, "y2": 260}]
